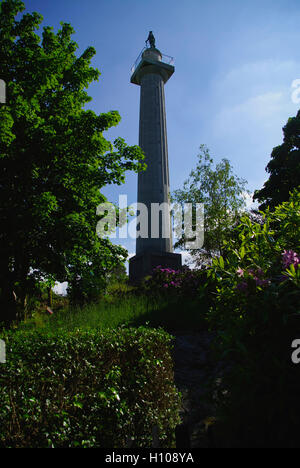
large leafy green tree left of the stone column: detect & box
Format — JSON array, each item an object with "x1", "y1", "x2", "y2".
[{"x1": 0, "y1": 0, "x2": 144, "y2": 321}]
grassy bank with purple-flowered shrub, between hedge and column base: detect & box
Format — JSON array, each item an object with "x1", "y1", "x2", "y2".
[{"x1": 17, "y1": 267, "x2": 211, "y2": 333}]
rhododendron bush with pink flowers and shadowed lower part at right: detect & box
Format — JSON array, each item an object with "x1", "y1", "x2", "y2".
[{"x1": 207, "y1": 191, "x2": 300, "y2": 447}]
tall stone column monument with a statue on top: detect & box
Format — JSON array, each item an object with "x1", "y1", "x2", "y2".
[{"x1": 129, "y1": 31, "x2": 181, "y2": 282}]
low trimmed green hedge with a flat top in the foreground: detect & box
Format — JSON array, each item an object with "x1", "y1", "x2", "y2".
[{"x1": 0, "y1": 327, "x2": 180, "y2": 448}]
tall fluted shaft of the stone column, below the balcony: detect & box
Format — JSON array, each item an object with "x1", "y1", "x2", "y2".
[{"x1": 136, "y1": 73, "x2": 173, "y2": 254}]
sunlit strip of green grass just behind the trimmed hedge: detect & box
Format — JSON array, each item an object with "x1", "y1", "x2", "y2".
[{"x1": 18, "y1": 295, "x2": 206, "y2": 332}]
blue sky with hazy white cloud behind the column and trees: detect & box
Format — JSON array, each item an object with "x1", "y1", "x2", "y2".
[{"x1": 25, "y1": 0, "x2": 300, "y2": 264}]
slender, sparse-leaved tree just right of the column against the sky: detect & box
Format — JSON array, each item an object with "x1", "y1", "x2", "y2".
[{"x1": 172, "y1": 145, "x2": 247, "y2": 265}]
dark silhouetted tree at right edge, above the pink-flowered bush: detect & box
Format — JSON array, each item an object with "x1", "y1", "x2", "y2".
[{"x1": 253, "y1": 111, "x2": 300, "y2": 210}]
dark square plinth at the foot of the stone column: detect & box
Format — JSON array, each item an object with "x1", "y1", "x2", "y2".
[{"x1": 129, "y1": 252, "x2": 181, "y2": 283}]
